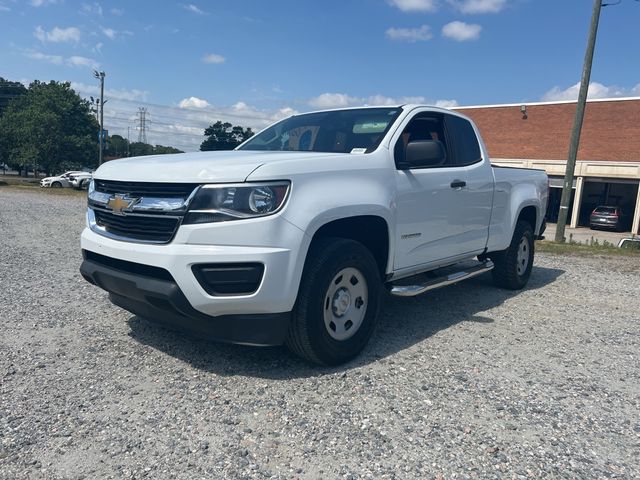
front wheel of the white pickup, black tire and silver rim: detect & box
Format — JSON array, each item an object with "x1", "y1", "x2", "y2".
[{"x1": 286, "y1": 238, "x2": 382, "y2": 365}]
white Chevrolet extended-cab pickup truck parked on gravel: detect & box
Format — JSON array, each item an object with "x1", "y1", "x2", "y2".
[{"x1": 80, "y1": 105, "x2": 548, "y2": 364}]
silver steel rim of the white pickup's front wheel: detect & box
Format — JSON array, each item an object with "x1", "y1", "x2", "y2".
[{"x1": 323, "y1": 267, "x2": 369, "y2": 341}]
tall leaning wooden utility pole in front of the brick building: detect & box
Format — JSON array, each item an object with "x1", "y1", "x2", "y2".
[{"x1": 555, "y1": 0, "x2": 602, "y2": 242}]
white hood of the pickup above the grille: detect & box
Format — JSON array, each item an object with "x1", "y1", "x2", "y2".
[{"x1": 93, "y1": 150, "x2": 349, "y2": 183}]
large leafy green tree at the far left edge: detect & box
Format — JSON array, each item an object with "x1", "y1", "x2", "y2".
[{"x1": 0, "y1": 80, "x2": 99, "y2": 173}]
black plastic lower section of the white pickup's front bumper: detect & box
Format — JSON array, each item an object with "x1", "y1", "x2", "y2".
[{"x1": 80, "y1": 252, "x2": 290, "y2": 345}]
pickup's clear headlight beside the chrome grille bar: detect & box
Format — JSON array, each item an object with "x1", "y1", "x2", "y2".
[{"x1": 182, "y1": 182, "x2": 290, "y2": 224}]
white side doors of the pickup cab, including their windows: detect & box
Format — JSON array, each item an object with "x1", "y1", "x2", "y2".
[{"x1": 393, "y1": 111, "x2": 493, "y2": 270}]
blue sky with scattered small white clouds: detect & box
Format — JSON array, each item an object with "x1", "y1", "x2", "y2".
[{"x1": 0, "y1": 0, "x2": 640, "y2": 150}]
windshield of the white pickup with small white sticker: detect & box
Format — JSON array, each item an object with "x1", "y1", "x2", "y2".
[{"x1": 238, "y1": 107, "x2": 402, "y2": 153}]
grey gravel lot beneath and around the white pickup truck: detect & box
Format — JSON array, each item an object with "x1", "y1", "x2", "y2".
[{"x1": 0, "y1": 187, "x2": 640, "y2": 479}]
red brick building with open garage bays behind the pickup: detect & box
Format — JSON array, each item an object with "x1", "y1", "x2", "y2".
[{"x1": 456, "y1": 97, "x2": 640, "y2": 233}]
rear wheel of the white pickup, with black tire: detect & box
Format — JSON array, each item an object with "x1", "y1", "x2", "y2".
[{"x1": 488, "y1": 220, "x2": 535, "y2": 290}]
